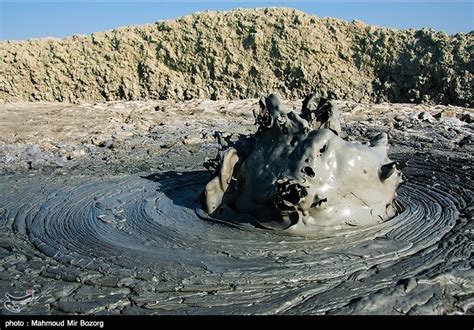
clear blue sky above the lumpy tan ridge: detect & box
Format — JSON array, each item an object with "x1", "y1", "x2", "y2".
[{"x1": 0, "y1": 0, "x2": 474, "y2": 40}]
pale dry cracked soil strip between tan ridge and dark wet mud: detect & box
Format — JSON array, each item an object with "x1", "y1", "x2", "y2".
[{"x1": 0, "y1": 99, "x2": 473, "y2": 172}]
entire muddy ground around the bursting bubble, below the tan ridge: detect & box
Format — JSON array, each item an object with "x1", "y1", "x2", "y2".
[{"x1": 0, "y1": 99, "x2": 474, "y2": 314}]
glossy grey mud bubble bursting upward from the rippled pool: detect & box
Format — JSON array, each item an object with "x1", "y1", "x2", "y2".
[{"x1": 204, "y1": 93, "x2": 402, "y2": 234}]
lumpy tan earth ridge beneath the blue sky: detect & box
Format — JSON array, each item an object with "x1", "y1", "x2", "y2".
[{"x1": 0, "y1": 8, "x2": 474, "y2": 107}]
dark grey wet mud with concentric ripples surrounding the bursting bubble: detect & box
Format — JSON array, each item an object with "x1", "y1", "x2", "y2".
[{"x1": 0, "y1": 100, "x2": 474, "y2": 314}]
